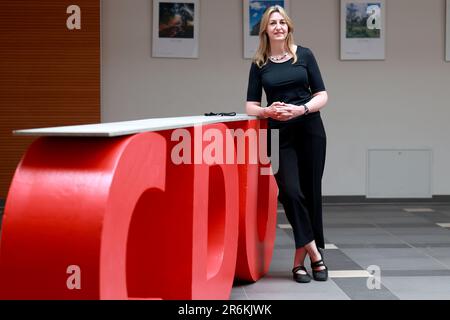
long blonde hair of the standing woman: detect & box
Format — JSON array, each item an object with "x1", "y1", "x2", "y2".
[{"x1": 253, "y1": 5, "x2": 297, "y2": 68}]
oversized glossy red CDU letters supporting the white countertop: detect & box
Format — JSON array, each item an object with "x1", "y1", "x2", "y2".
[{"x1": 0, "y1": 121, "x2": 276, "y2": 299}]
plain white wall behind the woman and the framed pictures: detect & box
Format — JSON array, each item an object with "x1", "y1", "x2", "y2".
[{"x1": 102, "y1": 0, "x2": 450, "y2": 195}]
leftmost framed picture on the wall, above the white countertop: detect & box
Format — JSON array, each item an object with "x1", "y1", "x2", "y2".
[{"x1": 152, "y1": 0, "x2": 200, "y2": 58}]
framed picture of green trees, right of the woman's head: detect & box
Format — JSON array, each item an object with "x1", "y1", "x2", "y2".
[{"x1": 341, "y1": 0, "x2": 386, "y2": 60}]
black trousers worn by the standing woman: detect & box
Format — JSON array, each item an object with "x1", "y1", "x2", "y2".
[{"x1": 275, "y1": 114, "x2": 326, "y2": 249}]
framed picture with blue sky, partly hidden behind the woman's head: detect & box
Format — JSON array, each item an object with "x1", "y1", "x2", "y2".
[{"x1": 244, "y1": 0, "x2": 289, "y2": 59}]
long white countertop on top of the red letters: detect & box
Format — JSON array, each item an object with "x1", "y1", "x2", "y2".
[{"x1": 13, "y1": 114, "x2": 258, "y2": 137}]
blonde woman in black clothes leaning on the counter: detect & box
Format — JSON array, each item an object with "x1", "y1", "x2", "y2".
[{"x1": 246, "y1": 6, "x2": 328, "y2": 282}]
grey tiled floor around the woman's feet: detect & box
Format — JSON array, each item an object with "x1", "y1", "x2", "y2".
[{"x1": 231, "y1": 203, "x2": 450, "y2": 300}]
